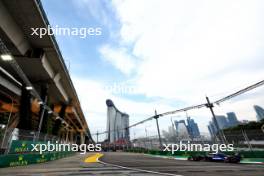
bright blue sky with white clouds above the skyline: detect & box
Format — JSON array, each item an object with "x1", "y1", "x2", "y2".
[{"x1": 42, "y1": 0, "x2": 264, "y2": 138}]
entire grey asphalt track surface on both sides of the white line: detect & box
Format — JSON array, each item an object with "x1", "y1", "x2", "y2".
[{"x1": 0, "y1": 152, "x2": 264, "y2": 176}]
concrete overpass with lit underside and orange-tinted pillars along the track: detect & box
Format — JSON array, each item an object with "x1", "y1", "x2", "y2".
[{"x1": 0, "y1": 0, "x2": 92, "y2": 148}]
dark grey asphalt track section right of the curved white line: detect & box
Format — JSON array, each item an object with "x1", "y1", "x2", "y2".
[{"x1": 100, "y1": 152, "x2": 264, "y2": 176}]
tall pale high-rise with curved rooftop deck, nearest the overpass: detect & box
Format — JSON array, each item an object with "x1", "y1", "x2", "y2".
[{"x1": 106, "y1": 100, "x2": 129, "y2": 142}]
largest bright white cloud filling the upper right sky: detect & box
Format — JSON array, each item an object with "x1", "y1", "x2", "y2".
[{"x1": 110, "y1": 0, "x2": 264, "y2": 102}]
